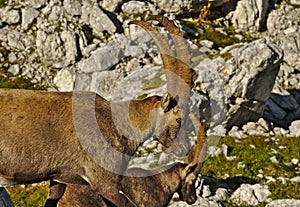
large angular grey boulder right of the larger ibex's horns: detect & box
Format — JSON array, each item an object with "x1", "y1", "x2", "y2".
[{"x1": 220, "y1": 39, "x2": 283, "y2": 129}]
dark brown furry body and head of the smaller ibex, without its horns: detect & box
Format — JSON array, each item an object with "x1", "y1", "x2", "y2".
[{"x1": 58, "y1": 163, "x2": 196, "y2": 207}]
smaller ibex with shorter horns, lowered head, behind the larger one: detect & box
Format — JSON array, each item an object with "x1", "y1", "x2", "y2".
[{"x1": 55, "y1": 114, "x2": 207, "y2": 207}]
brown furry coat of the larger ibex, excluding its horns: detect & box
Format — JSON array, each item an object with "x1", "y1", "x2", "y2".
[{"x1": 0, "y1": 89, "x2": 186, "y2": 206}]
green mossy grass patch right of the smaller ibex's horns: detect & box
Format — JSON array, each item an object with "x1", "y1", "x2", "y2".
[{"x1": 201, "y1": 136, "x2": 300, "y2": 199}]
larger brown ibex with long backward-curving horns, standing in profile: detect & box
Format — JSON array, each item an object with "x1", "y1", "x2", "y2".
[{"x1": 0, "y1": 15, "x2": 194, "y2": 206}]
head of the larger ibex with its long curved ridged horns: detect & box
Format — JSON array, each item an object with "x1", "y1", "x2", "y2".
[{"x1": 131, "y1": 16, "x2": 195, "y2": 156}]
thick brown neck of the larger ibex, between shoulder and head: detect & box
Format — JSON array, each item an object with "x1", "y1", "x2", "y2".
[{"x1": 96, "y1": 96, "x2": 160, "y2": 155}]
